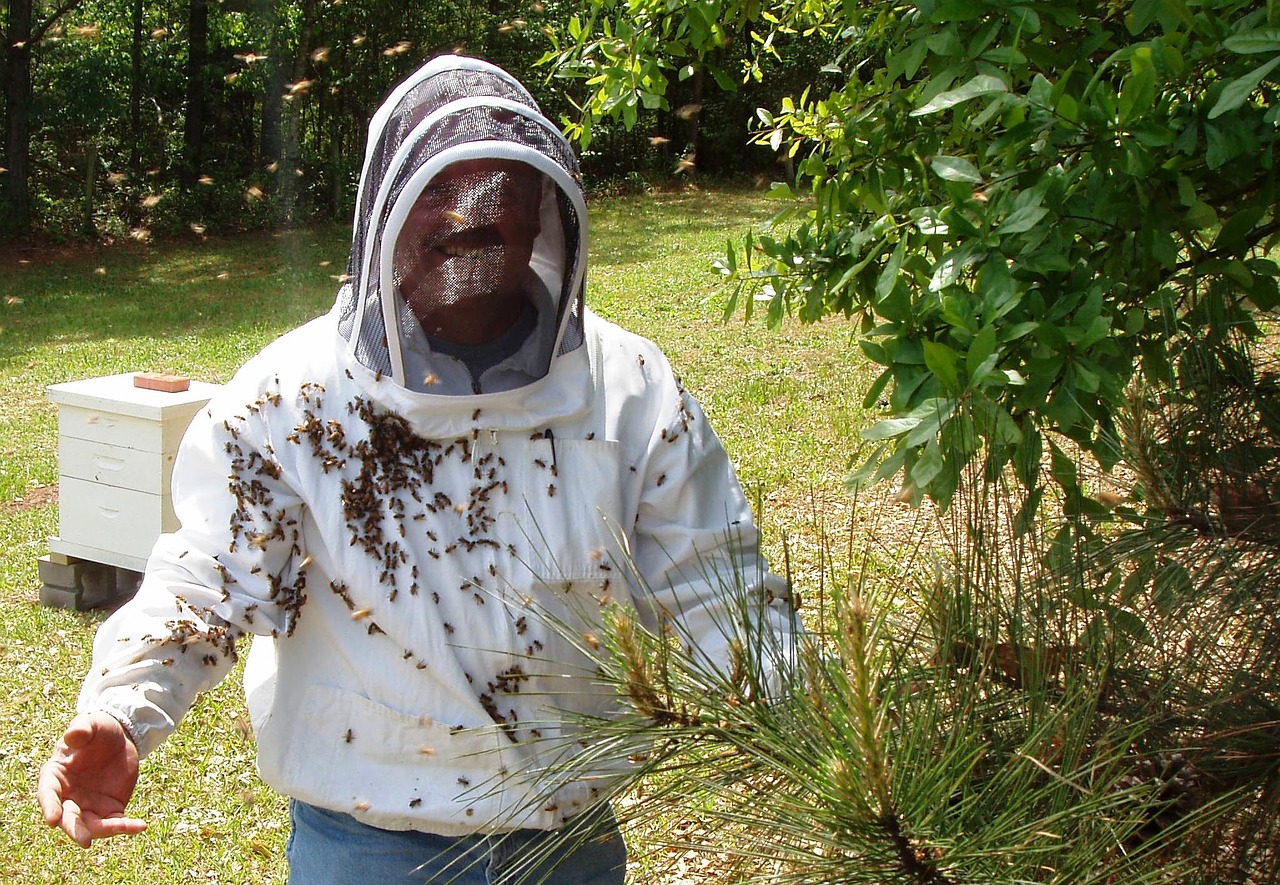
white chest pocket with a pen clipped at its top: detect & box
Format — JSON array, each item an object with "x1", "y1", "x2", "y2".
[{"x1": 488, "y1": 438, "x2": 635, "y2": 585}]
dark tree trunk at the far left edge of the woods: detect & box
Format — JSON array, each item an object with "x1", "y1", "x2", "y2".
[{"x1": 0, "y1": 0, "x2": 32, "y2": 233}]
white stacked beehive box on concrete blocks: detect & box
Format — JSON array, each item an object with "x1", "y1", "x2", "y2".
[{"x1": 47, "y1": 373, "x2": 219, "y2": 571}]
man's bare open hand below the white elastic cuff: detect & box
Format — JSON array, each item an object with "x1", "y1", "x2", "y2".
[{"x1": 36, "y1": 713, "x2": 147, "y2": 848}]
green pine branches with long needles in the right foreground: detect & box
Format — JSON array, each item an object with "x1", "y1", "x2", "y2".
[{"x1": 514, "y1": 455, "x2": 1280, "y2": 885}]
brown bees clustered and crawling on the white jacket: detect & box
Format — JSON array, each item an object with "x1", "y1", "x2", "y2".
[{"x1": 148, "y1": 363, "x2": 694, "y2": 753}]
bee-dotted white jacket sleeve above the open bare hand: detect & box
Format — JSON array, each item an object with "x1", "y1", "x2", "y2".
[{"x1": 78, "y1": 391, "x2": 306, "y2": 756}]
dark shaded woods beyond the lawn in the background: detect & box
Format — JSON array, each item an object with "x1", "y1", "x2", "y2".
[{"x1": 0, "y1": 0, "x2": 820, "y2": 238}]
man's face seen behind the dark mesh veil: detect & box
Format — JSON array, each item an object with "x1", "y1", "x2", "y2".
[{"x1": 396, "y1": 159, "x2": 541, "y2": 345}]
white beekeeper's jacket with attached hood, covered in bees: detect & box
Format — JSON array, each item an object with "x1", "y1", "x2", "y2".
[{"x1": 79, "y1": 56, "x2": 794, "y2": 835}]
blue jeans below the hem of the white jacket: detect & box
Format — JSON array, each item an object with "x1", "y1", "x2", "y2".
[{"x1": 285, "y1": 800, "x2": 627, "y2": 885}]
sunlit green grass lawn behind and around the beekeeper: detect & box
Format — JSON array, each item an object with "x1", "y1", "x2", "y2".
[{"x1": 0, "y1": 183, "x2": 874, "y2": 885}]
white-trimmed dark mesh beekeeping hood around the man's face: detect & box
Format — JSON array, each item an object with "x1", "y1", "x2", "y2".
[{"x1": 335, "y1": 55, "x2": 586, "y2": 407}]
